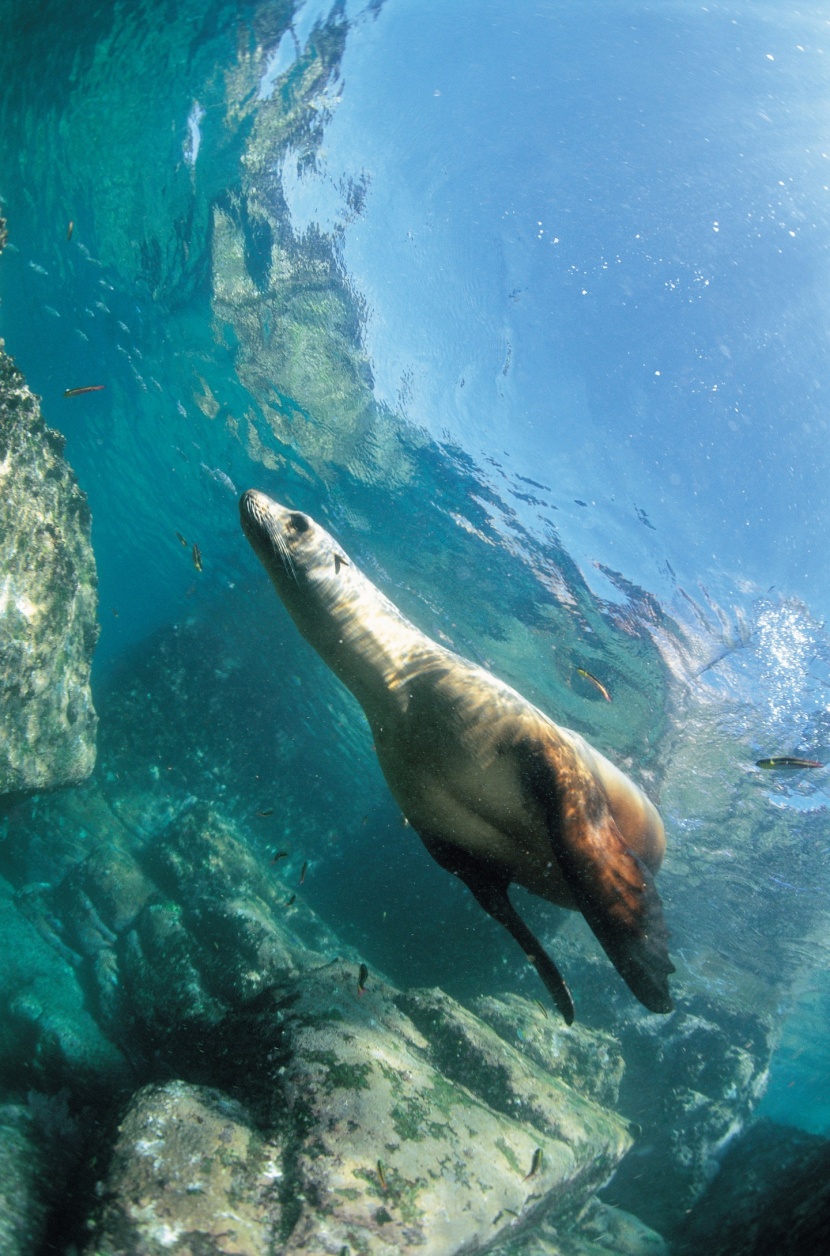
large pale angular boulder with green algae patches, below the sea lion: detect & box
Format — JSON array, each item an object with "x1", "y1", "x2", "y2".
[{"x1": 272, "y1": 965, "x2": 630, "y2": 1256}]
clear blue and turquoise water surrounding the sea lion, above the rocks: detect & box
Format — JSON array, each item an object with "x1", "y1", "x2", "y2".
[{"x1": 0, "y1": 0, "x2": 830, "y2": 1250}]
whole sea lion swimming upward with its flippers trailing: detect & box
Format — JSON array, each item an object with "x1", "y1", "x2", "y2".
[{"x1": 240, "y1": 490, "x2": 674, "y2": 1025}]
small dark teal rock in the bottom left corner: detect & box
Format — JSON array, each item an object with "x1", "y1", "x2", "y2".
[{"x1": 0, "y1": 1105, "x2": 48, "y2": 1256}]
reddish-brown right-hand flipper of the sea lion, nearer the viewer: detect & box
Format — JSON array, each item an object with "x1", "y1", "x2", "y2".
[{"x1": 522, "y1": 745, "x2": 674, "y2": 1012}]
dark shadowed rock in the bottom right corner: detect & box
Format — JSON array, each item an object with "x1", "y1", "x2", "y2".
[{"x1": 674, "y1": 1120, "x2": 830, "y2": 1256}]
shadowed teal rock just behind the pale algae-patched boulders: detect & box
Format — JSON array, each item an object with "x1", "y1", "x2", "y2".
[{"x1": 119, "y1": 803, "x2": 340, "y2": 1070}]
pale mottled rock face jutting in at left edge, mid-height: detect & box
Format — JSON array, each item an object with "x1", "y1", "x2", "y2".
[{"x1": 0, "y1": 343, "x2": 98, "y2": 795}]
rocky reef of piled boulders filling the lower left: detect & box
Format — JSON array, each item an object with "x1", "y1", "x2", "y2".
[{"x1": 1, "y1": 786, "x2": 640, "y2": 1256}]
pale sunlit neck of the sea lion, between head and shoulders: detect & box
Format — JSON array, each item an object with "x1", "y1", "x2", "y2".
[{"x1": 278, "y1": 565, "x2": 450, "y2": 722}]
